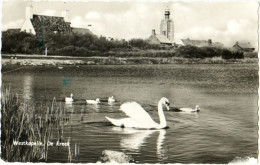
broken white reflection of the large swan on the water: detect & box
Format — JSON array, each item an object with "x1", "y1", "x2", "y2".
[{"x1": 112, "y1": 127, "x2": 168, "y2": 160}]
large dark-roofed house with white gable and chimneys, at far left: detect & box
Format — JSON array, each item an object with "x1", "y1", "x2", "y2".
[{"x1": 21, "y1": 6, "x2": 92, "y2": 36}]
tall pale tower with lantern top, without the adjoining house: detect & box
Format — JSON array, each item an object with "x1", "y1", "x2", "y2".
[{"x1": 160, "y1": 9, "x2": 174, "y2": 42}]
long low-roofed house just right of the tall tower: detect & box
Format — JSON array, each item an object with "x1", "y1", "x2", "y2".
[{"x1": 182, "y1": 38, "x2": 224, "y2": 48}]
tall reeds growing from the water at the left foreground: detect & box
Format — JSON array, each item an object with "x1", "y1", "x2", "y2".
[{"x1": 1, "y1": 85, "x2": 79, "y2": 162}]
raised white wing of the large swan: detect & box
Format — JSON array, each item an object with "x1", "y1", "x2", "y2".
[{"x1": 120, "y1": 102, "x2": 154, "y2": 124}]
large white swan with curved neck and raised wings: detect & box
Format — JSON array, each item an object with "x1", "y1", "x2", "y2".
[{"x1": 105, "y1": 97, "x2": 170, "y2": 129}]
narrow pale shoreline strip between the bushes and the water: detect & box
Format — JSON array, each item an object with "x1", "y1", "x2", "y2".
[{"x1": 1, "y1": 54, "x2": 258, "y2": 66}]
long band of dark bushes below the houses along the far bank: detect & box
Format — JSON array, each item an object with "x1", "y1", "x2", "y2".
[{"x1": 2, "y1": 31, "x2": 248, "y2": 59}]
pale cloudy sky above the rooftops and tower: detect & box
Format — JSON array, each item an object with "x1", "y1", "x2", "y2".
[{"x1": 2, "y1": 0, "x2": 259, "y2": 47}]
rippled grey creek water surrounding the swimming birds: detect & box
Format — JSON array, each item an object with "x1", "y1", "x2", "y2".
[{"x1": 2, "y1": 64, "x2": 258, "y2": 163}]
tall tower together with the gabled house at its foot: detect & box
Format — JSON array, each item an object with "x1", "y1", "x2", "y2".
[{"x1": 148, "y1": 9, "x2": 174, "y2": 46}]
